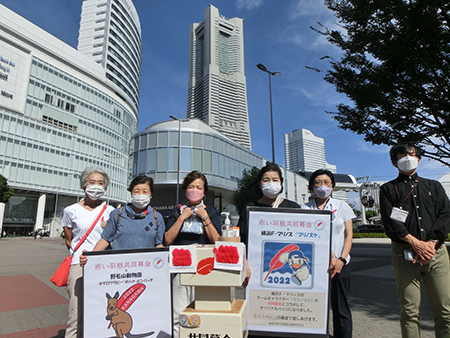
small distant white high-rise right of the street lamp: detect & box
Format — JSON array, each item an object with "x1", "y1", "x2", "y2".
[{"x1": 284, "y1": 129, "x2": 336, "y2": 173}]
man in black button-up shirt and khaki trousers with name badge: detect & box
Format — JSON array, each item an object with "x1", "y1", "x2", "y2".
[{"x1": 380, "y1": 144, "x2": 450, "y2": 338}]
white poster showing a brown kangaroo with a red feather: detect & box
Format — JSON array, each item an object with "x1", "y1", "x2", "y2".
[{"x1": 84, "y1": 248, "x2": 172, "y2": 338}]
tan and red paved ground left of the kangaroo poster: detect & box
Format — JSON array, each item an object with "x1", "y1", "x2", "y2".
[{"x1": 0, "y1": 237, "x2": 68, "y2": 338}]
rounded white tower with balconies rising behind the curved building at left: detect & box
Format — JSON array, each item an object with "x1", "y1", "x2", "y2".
[{"x1": 77, "y1": 0, "x2": 142, "y2": 114}]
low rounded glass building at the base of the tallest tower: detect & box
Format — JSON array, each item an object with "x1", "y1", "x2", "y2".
[{"x1": 131, "y1": 119, "x2": 307, "y2": 216}]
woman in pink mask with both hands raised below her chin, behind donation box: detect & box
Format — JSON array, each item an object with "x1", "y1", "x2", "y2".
[{"x1": 164, "y1": 171, "x2": 222, "y2": 338}]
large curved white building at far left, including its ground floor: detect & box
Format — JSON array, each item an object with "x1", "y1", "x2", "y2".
[{"x1": 0, "y1": 1, "x2": 138, "y2": 236}]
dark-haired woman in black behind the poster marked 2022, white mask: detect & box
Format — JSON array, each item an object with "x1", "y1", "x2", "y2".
[{"x1": 238, "y1": 162, "x2": 300, "y2": 245}]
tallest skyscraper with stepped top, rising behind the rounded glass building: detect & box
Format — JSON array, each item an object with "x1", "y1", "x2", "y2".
[{"x1": 186, "y1": 5, "x2": 251, "y2": 149}]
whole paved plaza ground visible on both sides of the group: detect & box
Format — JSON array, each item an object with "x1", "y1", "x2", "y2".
[{"x1": 0, "y1": 238, "x2": 442, "y2": 338}]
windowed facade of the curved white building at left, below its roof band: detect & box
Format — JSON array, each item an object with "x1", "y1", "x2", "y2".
[{"x1": 0, "y1": 57, "x2": 137, "y2": 201}]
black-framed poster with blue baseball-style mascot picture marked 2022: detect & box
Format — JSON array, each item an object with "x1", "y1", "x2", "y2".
[{"x1": 246, "y1": 207, "x2": 331, "y2": 335}]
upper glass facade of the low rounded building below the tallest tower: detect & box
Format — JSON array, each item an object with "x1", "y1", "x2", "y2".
[{"x1": 132, "y1": 120, "x2": 265, "y2": 190}]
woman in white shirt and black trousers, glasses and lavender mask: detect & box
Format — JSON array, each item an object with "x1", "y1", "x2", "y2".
[{"x1": 301, "y1": 169, "x2": 356, "y2": 338}]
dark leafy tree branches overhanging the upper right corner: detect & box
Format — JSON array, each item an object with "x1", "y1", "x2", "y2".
[{"x1": 312, "y1": 0, "x2": 450, "y2": 166}]
